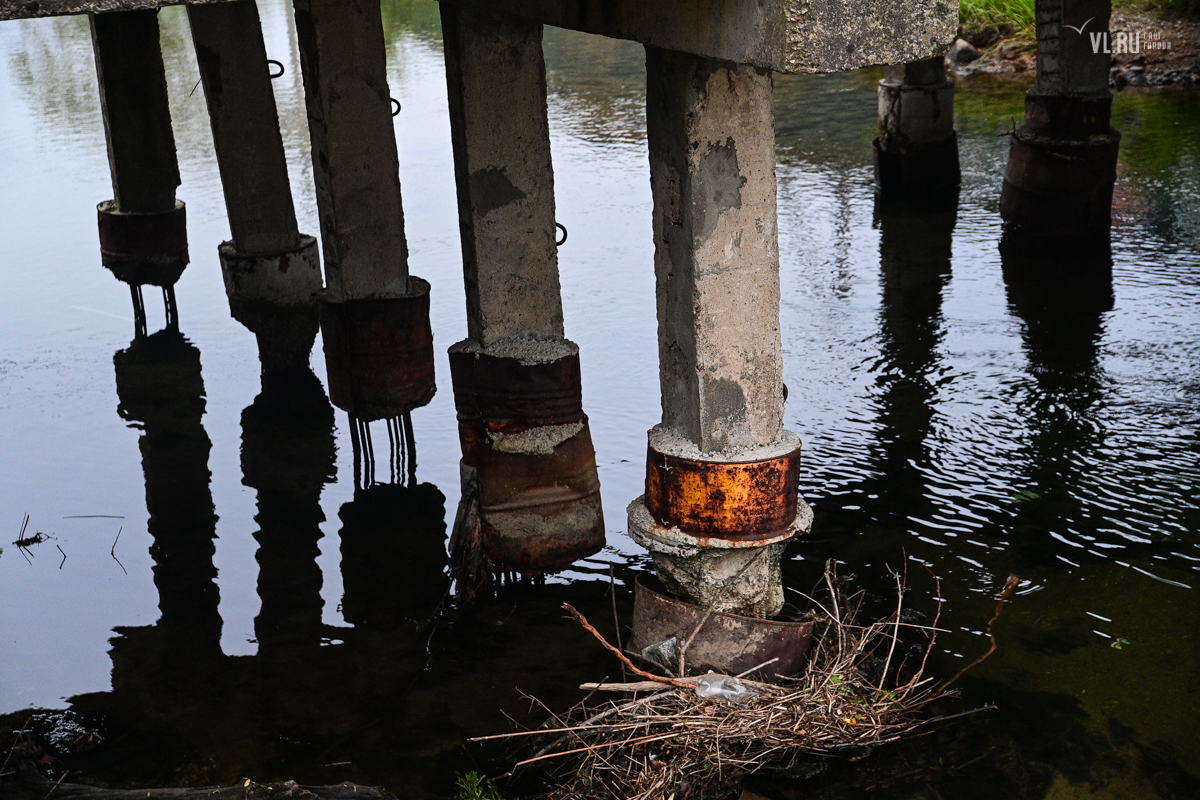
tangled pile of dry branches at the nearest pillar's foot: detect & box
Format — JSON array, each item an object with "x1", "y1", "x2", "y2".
[{"x1": 472, "y1": 564, "x2": 1018, "y2": 800}]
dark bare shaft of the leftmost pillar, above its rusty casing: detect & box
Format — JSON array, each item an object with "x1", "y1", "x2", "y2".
[{"x1": 90, "y1": 11, "x2": 179, "y2": 213}]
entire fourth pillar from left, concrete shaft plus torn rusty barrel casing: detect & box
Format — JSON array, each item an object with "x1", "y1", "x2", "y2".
[{"x1": 442, "y1": 4, "x2": 605, "y2": 575}]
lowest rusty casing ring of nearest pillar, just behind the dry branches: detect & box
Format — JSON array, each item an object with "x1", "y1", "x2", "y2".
[{"x1": 629, "y1": 577, "x2": 812, "y2": 681}]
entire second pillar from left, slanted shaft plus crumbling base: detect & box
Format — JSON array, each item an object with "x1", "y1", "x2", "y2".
[{"x1": 187, "y1": 0, "x2": 322, "y2": 372}]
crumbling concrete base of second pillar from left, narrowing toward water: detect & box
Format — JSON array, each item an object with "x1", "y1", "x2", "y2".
[{"x1": 217, "y1": 234, "x2": 322, "y2": 372}]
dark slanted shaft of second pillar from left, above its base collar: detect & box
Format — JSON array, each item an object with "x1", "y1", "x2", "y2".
[{"x1": 187, "y1": 0, "x2": 300, "y2": 255}]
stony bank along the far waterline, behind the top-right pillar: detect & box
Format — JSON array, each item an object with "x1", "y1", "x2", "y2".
[{"x1": 947, "y1": 12, "x2": 1200, "y2": 89}]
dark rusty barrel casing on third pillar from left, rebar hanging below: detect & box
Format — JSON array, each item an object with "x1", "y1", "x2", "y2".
[{"x1": 318, "y1": 277, "x2": 437, "y2": 421}]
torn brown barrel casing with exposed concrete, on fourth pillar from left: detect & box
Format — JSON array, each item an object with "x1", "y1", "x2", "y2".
[{"x1": 450, "y1": 347, "x2": 605, "y2": 575}]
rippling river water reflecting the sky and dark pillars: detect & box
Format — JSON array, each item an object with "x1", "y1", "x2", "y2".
[{"x1": 0, "y1": 0, "x2": 1200, "y2": 798}]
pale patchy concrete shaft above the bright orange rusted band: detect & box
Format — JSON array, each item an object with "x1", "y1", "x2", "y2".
[{"x1": 646, "y1": 48, "x2": 784, "y2": 453}]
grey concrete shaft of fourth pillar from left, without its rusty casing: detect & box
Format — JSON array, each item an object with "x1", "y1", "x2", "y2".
[{"x1": 442, "y1": 4, "x2": 563, "y2": 348}]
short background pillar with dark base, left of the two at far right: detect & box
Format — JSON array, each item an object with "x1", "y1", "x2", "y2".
[{"x1": 871, "y1": 56, "x2": 961, "y2": 197}]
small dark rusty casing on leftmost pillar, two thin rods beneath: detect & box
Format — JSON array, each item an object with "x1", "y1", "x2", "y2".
[{"x1": 96, "y1": 200, "x2": 188, "y2": 288}]
